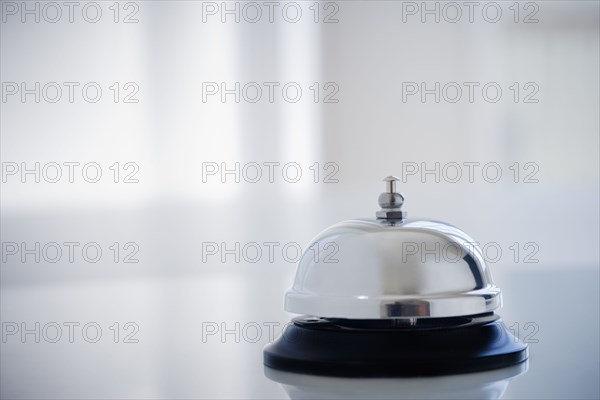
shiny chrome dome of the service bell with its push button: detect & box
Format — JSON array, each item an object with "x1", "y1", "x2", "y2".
[{"x1": 285, "y1": 176, "x2": 501, "y2": 319}]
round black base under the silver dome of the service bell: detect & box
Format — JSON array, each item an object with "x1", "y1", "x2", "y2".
[{"x1": 264, "y1": 317, "x2": 528, "y2": 377}]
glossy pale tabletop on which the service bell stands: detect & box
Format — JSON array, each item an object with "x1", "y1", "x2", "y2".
[{"x1": 1, "y1": 258, "x2": 599, "y2": 399}]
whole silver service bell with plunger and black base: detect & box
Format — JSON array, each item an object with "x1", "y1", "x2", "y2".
[{"x1": 264, "y1": 177, "x2": 527, "y2": 376}]
